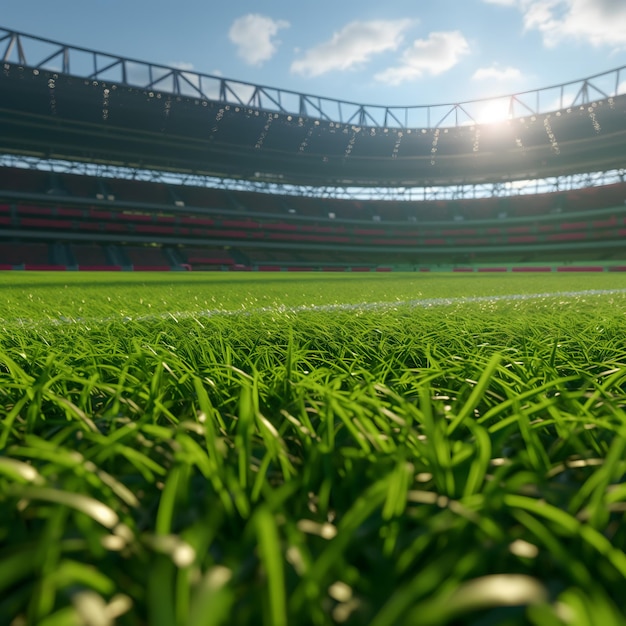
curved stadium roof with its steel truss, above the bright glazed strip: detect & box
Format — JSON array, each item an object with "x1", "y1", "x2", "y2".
[{"x1": 0, "y1": 29, "x2": 626, "y2": 187}]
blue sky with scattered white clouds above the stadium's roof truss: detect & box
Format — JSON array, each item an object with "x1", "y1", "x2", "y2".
[{"x1": 0, "y1": 0, "x2": 626, "y2": 113}]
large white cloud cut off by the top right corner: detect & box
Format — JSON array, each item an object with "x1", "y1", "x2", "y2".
[{"x1": 483, "y1": 0, "x2": 626, "y2": 49}]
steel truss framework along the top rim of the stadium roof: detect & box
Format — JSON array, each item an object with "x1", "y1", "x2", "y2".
[{"x1": 0, "y1": 28, "x2": 626, "y2": 129}]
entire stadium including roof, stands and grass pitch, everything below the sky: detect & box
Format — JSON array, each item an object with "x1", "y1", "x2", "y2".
[{"x1": 0, "y1": 23, "x2": 626, "y2": 626}]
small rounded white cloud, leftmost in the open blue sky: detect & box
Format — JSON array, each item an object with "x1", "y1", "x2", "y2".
[{"x1": 228, "y1": 13, "x2": 289, "y2": 65}]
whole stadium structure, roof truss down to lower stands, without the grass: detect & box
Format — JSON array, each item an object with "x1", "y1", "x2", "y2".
[{"x1": 0, "y1": 29, "x2": 626, "y2": 271}]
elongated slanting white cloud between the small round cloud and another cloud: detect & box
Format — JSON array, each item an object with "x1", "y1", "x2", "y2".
[{"x1": 291, "y1": 19, "x2": 413, "y2": 76}]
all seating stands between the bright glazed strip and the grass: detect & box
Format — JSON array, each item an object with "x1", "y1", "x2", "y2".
[{"x1": 0, "y1": 168, "x2": 626, "y2": 270}]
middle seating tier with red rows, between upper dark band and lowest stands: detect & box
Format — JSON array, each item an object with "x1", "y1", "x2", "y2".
[{"x1": 0, "y1": 203, "x2": 626, "y2": 247}]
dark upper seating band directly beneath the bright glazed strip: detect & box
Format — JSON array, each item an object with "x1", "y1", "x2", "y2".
[{"x1": 0, "y1": 167, "x2": 626, "y2": 224}]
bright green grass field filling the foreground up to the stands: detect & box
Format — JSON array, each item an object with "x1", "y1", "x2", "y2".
[{"x1": 0, "y1": 272, "x2": 626, "y2": 626}]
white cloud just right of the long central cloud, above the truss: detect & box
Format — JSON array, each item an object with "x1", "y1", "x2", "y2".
[{"x1": 375, "y1": 30, "x2": 469, "y2": 85}]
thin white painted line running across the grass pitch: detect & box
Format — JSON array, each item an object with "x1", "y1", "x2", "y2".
[{"x1": 0, "y1": 289, "x2": 626, "y2": 326}]
